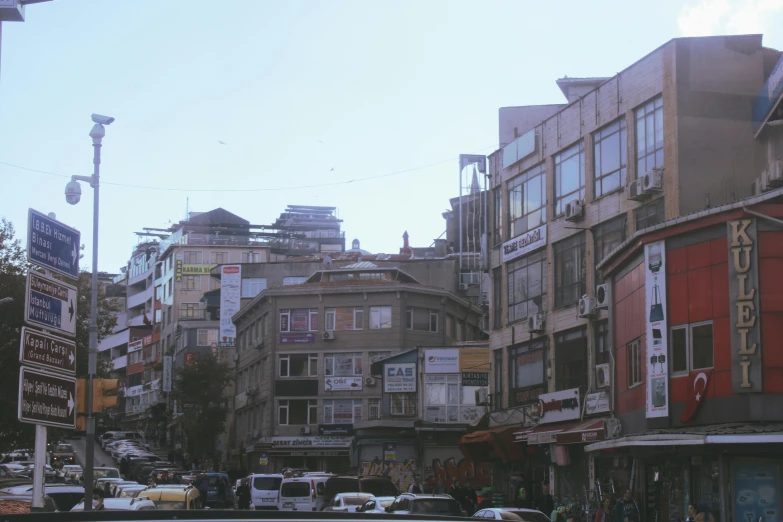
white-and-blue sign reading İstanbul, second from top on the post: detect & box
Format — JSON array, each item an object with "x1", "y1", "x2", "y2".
[{"x1": 24, "y1": 272, "x2": 77, "y2": 337}]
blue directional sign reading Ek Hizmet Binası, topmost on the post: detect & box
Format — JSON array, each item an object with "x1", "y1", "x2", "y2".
[{"x1": 27, "y1": 209, "x2": 81, "y2": 279}]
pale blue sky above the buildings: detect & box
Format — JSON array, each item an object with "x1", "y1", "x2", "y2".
[{"x1": 0, "y1": 0, "x2": 783, "y2": 272}]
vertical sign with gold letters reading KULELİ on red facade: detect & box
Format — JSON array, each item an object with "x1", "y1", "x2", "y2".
[{"x1": 728, "y1": 218, "x2": 763, "y2": 393}]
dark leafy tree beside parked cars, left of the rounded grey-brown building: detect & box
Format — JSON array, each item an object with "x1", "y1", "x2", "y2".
[{"x1": 172, "y1": 355, "x2": 233, "y2": 462}]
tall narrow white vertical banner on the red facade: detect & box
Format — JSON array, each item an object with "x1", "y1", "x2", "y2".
[{"x1": 640, "y1": 241, "x2": 669, "y2": 419}]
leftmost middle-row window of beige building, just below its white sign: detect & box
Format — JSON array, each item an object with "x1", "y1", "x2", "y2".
[{"x1": 507, "y1": 251, "x2": 546, "y2": 323}]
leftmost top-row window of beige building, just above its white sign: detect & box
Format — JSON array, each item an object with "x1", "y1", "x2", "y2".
[{"x1": 508, "y1": 163, "x2": 546, "y2": 239}]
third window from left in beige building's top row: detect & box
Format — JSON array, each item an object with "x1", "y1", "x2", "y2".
[{"x1": 593, "y1": 119, "x2": 628, "y2": 199}]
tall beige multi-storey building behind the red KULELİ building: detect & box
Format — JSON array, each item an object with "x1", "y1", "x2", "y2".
[{"x1": 463, "y1": 35, "x2": 780, "y2": 506}]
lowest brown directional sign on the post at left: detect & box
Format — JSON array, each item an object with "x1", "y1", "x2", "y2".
[{"x1": 18, "y1": 366, "x2": 76, "y2": 428}]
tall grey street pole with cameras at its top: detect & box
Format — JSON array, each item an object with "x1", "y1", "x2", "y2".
[{"x1": 65, "y1": 114, "x2": 114, "y2": 511}]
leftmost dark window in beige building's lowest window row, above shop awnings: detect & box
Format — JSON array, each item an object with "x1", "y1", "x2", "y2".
[{"x1": 508, "y1": 337, "x2": 546, "y2": 406}]
